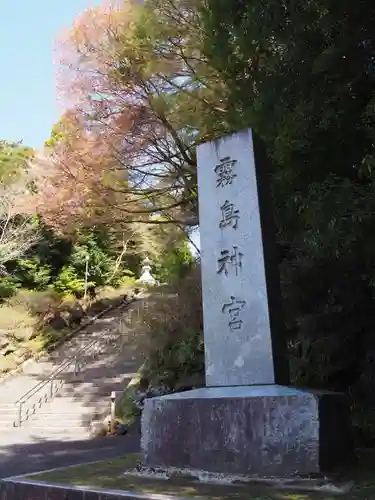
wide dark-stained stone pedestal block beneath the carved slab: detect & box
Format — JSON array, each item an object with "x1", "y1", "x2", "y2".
[{"x1": 142, "y1": 385, "x2": 353, "y2": 477}]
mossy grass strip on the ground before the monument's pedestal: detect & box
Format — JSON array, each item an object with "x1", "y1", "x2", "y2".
[{"x1": 24, "y1": 453, "x2": 375, "y2": 500}]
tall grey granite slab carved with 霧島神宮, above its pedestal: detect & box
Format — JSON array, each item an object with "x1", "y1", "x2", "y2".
[{"x1": 197, "y1": 130, "x2": 288, "y2": 387}]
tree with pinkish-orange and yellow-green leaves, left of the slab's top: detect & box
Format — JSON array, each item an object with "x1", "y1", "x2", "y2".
[{"x1": 36, "y1": 0, "x2": 229, "y2": 238}]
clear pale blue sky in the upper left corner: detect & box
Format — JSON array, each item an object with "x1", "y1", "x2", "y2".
[{"x1": 0, "y1": 0, "x2": 99, "y2": 147}]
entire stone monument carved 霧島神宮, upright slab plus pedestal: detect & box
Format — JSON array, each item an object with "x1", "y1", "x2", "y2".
[{"x1": 142, "y1": 130, "x2": 352, "y2": 476}]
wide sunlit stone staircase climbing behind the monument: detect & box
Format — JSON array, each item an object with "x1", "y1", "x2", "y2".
[{"x1": 0, "y1": 299, "x2": 143, "y2": 444}]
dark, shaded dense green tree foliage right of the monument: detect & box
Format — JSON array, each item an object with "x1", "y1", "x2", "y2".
[{"x1": 201, "y1": 0, "x2": 375, "y2": 432}]
